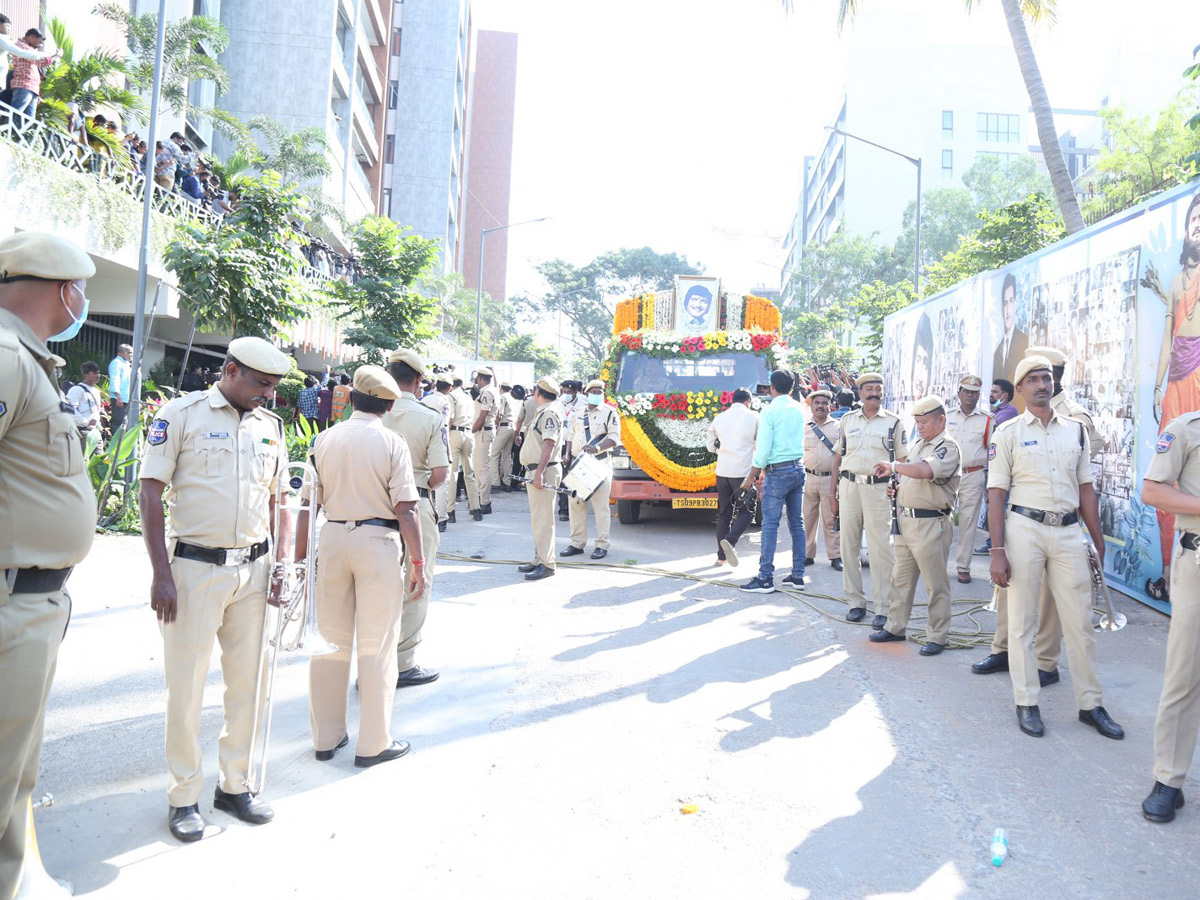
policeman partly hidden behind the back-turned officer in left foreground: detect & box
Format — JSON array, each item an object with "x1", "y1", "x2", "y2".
[{"x1": 383, "y1": 348, "x2": 450, "y2": 688}]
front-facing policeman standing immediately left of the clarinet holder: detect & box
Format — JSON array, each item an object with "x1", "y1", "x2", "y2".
[{"x1": 829, "y1": 372, "x2": 905, "y2": 629}]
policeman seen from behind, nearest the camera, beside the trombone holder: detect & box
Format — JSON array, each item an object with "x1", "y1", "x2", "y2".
[{"x1": 296, "y1": 366, "x2": 426, "y2": 768}]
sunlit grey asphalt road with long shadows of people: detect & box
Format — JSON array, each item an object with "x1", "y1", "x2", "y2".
[{"x1": 35, "y1": 494, "x2": 1200, "y2": 900}]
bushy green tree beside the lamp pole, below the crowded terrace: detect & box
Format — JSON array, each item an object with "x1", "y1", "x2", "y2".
[{"x1": 163, "y1": 172, "x2": 314, "y2": 337}]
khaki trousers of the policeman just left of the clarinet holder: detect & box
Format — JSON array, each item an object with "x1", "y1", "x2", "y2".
[{"x1": 838, "y1": 479, "x2": 895, "y2": 616}]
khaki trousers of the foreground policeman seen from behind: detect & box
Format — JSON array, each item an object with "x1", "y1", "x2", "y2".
[{"x1": 308, "y1": 522, "x2": 404, "y2": 756}]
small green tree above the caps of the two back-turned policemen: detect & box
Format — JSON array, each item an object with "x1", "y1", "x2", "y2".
[{"x1": 324, "y1": 216, "x2": 438, "y2": 365}]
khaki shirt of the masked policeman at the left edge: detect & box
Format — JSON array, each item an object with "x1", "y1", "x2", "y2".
[{"x1": 0, "y1": 310, "x2": 96, "y2": 566}]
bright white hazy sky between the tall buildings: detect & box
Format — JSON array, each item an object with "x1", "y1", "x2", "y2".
[{"x1": 473, "y1": 0, "x2": 1200, "y2": 314}]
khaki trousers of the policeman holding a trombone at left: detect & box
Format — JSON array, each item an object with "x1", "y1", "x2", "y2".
[{"x1": 158, "y1": 554, "x2": 271, "y2": 806}]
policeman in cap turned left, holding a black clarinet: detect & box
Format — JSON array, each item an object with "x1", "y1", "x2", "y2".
[{"x1": 870, "y1": 397, "x2": 960, "y2": 656}]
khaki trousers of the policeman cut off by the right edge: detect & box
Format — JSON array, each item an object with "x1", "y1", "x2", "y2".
[{"x1": 1154, "y1": 546, "x2": 1200, "y2": 787}]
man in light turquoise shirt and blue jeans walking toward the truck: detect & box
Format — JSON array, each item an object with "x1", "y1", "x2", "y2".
[{"x1": 742, "y1": 370, "x2": 804, "y2": 594}]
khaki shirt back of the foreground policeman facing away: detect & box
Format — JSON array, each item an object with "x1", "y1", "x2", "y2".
[{"x1": 310, "y1": 410, "x2": 418, "y2": 522}]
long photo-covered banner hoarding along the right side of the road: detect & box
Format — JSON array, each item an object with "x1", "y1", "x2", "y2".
[{"x1": 883, "y1": 181, "x2": 1200, "y2": 612}]
